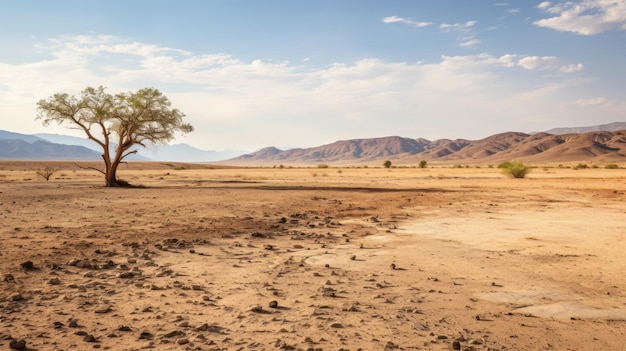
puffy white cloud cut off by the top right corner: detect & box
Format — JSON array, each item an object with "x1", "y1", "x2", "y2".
[{"x1": 534, "y1": 0, "x2": 626, "y2": 35}]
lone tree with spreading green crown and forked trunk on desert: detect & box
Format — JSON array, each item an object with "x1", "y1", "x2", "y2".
[{"x1": 36, "y1": 86, "x2": 193, "y2": 187}]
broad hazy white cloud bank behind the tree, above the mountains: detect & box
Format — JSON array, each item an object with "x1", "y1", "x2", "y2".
[{"x1": 0, "y1": 36, "x2": 623, "y2": 150}]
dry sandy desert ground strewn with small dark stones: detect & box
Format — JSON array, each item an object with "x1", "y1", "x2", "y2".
[{"x1": 0, "y1": 161, "x2": 626, "y2": 351}]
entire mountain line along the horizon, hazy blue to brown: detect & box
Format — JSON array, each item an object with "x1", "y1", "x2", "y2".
[{"x1": 0, "y1": 122, "x2": 626, "y2": 165}]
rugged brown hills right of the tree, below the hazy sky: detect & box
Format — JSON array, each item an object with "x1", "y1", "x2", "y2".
[{"x1": 228, "y1": 130, "x2": 626, "y2": 165}]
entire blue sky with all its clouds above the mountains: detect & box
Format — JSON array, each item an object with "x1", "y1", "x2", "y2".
[{"x1": 0, "y1": 0, "x2": 626, "y2": 151}]
